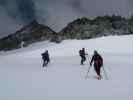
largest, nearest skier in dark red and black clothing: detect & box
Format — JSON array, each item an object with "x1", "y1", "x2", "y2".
[{"x1": 90, "y1": 50, "x2": 103, "y2": 79}]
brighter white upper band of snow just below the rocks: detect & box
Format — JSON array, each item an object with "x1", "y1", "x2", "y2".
[{"x1": 1, "y1": 35, "x2": 133, "y2": 57}]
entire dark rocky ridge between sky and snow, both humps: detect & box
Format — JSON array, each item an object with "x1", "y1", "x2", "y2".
[{"x1": 0, "y1": 15, "x2": 133, "y2": 50}]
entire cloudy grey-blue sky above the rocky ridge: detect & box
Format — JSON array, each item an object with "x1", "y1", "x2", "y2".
[{"x1": 0, "y1": 0, "x2": 133, "y2": 37}]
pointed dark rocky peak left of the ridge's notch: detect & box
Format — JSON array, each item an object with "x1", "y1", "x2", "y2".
[{"x1": 0, "y1": 20, "x2": 57, "y2": 50}]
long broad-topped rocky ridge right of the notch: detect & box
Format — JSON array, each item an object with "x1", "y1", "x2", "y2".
[{"x1": 59, "y1": 15, "x2": 133, "y2": 40}]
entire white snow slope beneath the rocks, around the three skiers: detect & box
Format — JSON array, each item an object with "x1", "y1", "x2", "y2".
[{"x1": 0, "y1": 36, "x2": 133, "y2": 100}]
